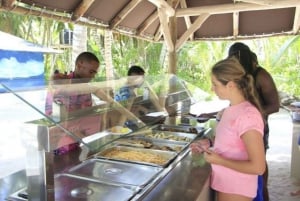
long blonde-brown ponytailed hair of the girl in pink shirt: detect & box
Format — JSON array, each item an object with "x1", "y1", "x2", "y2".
[{"x1": 211, "y1": 56, "x2": 264, "y2": 115}]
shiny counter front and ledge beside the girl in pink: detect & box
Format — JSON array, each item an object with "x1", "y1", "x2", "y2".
[{"x1": 136, "y1": 152, "x2": 213, "y2": 201}]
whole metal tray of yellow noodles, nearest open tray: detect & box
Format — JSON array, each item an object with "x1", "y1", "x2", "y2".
[{"x1": 95, "y1": 146, "x2": 177, "y2": 167}]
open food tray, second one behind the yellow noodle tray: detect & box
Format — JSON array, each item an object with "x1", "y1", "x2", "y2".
[{"x1": 143, "y1": 130, "x2": 197, "y2": 144}]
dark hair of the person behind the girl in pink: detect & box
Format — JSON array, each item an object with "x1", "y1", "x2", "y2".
[{"x1": 228, "y1": 42, "x2": 254, "y2": 75}]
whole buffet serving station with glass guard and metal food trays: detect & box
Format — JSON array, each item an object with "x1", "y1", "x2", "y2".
[{"x1": 1, "y1": 75, "x2": 214, "y2": 201}]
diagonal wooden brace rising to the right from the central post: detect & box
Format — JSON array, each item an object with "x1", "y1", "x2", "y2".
[{"x1": 175, "y1": 13, "x2": 210, "y2": 50}]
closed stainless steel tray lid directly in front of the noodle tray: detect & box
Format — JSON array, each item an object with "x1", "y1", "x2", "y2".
[{"x1": 68, "y1": 159, "x2": 162, "y2": 188}]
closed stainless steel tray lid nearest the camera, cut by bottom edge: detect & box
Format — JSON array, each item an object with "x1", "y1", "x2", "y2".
[{"x1": 54, "y1": 174, "x2": 139, "y2": 201}]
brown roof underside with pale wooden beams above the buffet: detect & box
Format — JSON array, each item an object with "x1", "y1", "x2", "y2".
[{"x1": 0, "y1": 0, "x2": 300, "y2": 71}]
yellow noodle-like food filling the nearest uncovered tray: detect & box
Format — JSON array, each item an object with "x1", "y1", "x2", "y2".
[{"x1": 102, "y1": 149, "x2": 167, "y2": 165}]
